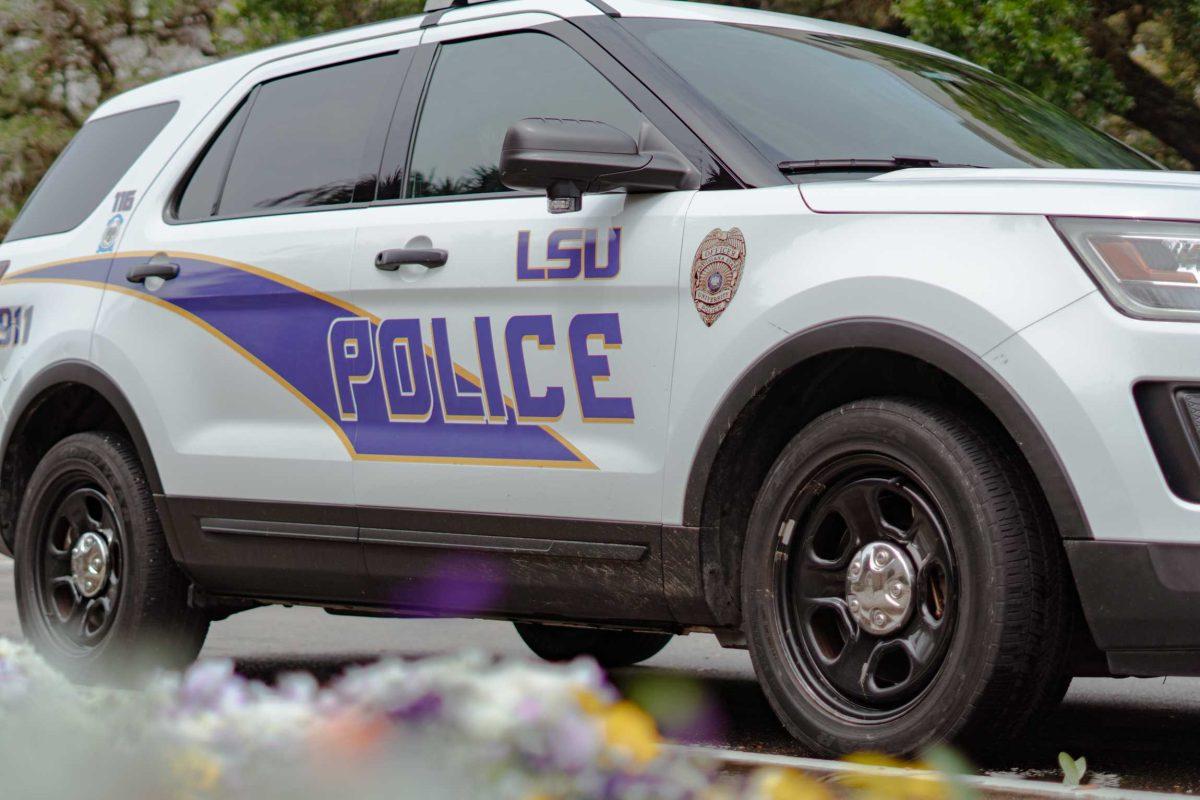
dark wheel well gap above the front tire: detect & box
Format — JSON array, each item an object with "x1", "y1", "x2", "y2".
[{"x1": 700, "y1": 348, "x2": 1060, "y2": 625}]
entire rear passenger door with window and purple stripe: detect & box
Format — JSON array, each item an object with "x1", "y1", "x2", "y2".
[{"x1": 95, "y1": 34, "x2": 420, "y2": 599}]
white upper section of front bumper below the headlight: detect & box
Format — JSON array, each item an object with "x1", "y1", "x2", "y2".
[{"x1": 984, "y1": 293, "x2": 1200, "y2": 546}]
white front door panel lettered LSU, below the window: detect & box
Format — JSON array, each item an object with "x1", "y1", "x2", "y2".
[{"x1": 343, "y1": 193, "x2": 691, "y2": 615}]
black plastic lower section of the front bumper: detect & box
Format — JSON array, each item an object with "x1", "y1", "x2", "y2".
[{"x1": 1067, "y1": 541, "x2": 1200, "y2": 675}]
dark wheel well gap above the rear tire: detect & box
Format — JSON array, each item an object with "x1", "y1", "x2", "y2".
[{"x1": 0, "y1": 383, "x2": 131, "y2": 549}]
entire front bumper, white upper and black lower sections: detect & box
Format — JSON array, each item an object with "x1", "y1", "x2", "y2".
[{"x1": 985, "y1": 293, "x2": 1200, "y2": 675}]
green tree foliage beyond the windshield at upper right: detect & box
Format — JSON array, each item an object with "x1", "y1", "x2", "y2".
[{"x1": 713, "y1": 0, "x2": 1200, "y2": 169}]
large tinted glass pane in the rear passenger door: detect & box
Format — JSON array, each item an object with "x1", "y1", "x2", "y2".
[{"x1": 217, "y1": 55, "x2": 407, "y2": 217}]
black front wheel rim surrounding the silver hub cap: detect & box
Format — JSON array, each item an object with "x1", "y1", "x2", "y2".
[{"x1": 773, "y1": 453, "x2": 959, "y2": 722}]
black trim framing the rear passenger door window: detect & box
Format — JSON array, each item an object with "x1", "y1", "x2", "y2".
[{"x1": 162, "y1": 50, "x2": 420, "y2": 225}]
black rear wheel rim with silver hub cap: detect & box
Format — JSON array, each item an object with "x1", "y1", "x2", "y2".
[{"x1": 34, "y1": 474, "x2": 125, "y2": 655}]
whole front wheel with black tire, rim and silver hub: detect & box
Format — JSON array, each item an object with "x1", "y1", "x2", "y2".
[{"x1": 742, "y1": 399, "x2": 1068, "y2": 756}]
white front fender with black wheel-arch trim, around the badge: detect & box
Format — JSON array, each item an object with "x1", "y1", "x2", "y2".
[{"x1": 665, "y1": 194, "x2": 1096, "y2": 537}]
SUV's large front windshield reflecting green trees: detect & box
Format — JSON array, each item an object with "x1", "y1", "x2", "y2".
[{"x1": 622, "y1": 19, "x2": 1158, "y2": 175}]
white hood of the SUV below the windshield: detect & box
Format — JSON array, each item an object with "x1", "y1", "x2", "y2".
[{"x1": 800, "y1": 169, "x2": 1200, "y2": 221}]
